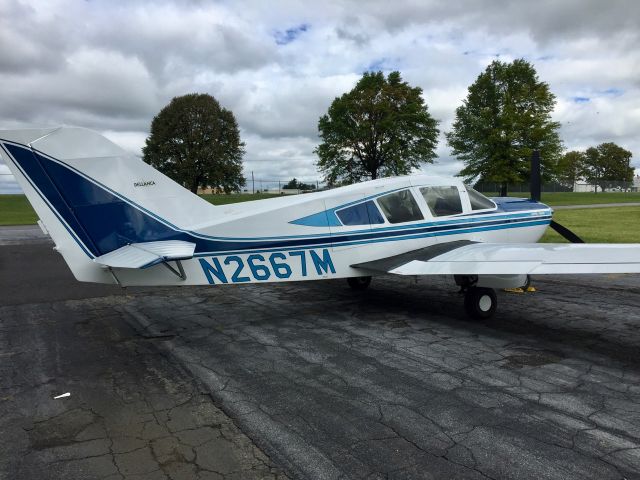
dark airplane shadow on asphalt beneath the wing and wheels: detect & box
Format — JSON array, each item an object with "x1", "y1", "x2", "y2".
[{"x1": 311, "y1": 277, "x2": 640, "y2": 367}]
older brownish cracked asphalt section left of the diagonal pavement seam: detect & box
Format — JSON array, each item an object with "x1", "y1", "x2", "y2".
[{"x1": 0, "y1": 241, "x2": 286, "y2": 480}]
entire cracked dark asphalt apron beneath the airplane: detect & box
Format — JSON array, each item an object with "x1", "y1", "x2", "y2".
[{"x1": 0, "y1": 231, "x2": 640, "y2": 479}]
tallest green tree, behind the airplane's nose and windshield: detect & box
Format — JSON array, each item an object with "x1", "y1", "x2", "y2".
[{"x1": 446, "y1": 59, "x2": 562, "y2": 195}]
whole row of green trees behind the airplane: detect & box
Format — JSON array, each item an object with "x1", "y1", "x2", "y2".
[{"x1": 143, "y1": 59, "x2": 633, "y2": 195}]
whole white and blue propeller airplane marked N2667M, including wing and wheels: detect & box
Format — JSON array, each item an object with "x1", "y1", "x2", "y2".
[{"x1": 0, "y1": 127, "x2": 640, "y2": 319}]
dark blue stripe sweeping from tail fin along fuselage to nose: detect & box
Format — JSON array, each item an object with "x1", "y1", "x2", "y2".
[{"x1": 4, "y1": 142, "x2": 551, "y2": 256}]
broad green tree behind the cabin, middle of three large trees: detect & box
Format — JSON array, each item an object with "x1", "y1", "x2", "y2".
[{"x1": 315, "y1": 72, "x2": 438, "y2": 185}]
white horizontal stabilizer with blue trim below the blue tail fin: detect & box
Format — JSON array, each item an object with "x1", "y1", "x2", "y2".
[{"x1": 93, "y1": 240, "x2": 196, "y2": 268}]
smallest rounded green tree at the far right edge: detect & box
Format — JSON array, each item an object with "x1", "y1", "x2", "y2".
[{"x1": 581, "y1": 142, "x2": 634, "y2": 191}]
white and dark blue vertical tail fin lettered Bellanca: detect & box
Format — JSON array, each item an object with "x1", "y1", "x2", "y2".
[{"x1": 0, "y1": 127, "x2": 215, "y2": 283}]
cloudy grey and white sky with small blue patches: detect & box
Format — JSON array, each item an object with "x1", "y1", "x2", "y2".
[{"x1": 0, "y1": 0, "x2": 640, "y2": 192}]
